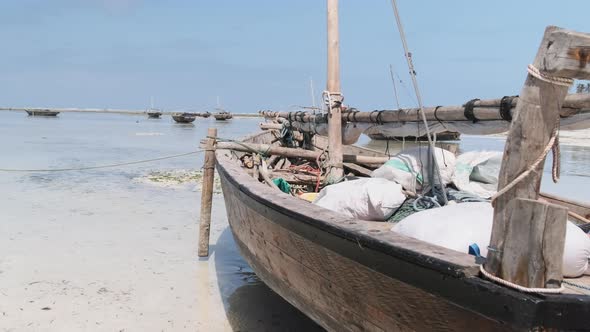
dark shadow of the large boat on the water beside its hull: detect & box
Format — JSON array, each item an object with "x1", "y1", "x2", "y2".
[{"x1": 211, "y1": 227, "x2": 324, "y2": 331}]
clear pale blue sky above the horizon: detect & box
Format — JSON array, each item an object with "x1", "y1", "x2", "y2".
[{"x1": 0, "y1": 0, "x2": 590, "y2": 113}]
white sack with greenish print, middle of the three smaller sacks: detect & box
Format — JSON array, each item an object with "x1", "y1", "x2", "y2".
[{"x1": 371, "y1": 148, "x2": 455, "y2": 193}]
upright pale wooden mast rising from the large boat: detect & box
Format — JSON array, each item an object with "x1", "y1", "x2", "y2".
[{"x1": 326, "y1": 0, "x2": 344, "y2": 183}]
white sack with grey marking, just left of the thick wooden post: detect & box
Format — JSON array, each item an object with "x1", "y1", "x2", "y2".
[{"x1": 453, "y1": 151, "x2": 503, "y2": 198}]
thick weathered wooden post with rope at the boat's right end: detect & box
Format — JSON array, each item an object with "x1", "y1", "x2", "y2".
[{"x1": 485, "y1": 26, "x2": 590, "y2": 288}]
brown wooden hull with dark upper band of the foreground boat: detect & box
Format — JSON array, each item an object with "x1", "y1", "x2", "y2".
[{"x1": 217, "y1": 131, "x2": 590, "y2": 331}]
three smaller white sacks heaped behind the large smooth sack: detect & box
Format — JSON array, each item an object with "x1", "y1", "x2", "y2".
[{"x1": 313, "y1": 148, "x2": 502, "y2": 221}]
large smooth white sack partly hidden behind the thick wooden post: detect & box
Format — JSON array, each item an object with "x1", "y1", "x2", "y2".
[{"x1": 392, "y1": 202, "x2": 590, "y2": 277}]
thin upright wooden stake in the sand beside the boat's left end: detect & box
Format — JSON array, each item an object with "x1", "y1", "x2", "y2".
[{"x1": 199, "y1": 128, "x2": 217, "y2": 257}]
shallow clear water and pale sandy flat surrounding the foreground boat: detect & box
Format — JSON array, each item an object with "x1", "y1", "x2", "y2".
[{"x1": 0, "y1": 112, "x2": 590, "y2": 331}]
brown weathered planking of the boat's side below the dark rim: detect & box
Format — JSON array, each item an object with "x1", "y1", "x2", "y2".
[{"x1": 226, "y1": 184, "x2": 498, "y2": 331}]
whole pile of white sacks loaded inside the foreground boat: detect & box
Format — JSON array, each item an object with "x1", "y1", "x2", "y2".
[{"x1": 314, "y1": 148, "x2": 590, "y2": 277}]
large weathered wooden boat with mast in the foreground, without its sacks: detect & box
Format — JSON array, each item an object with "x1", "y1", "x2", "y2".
[{"x1": 199, "y1": 0, "x2": 590, "y2": 331}]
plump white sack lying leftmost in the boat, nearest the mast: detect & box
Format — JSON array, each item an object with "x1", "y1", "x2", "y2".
[{"x1": 313, "y1": 178, "x2": 406, "y2": 221}]
